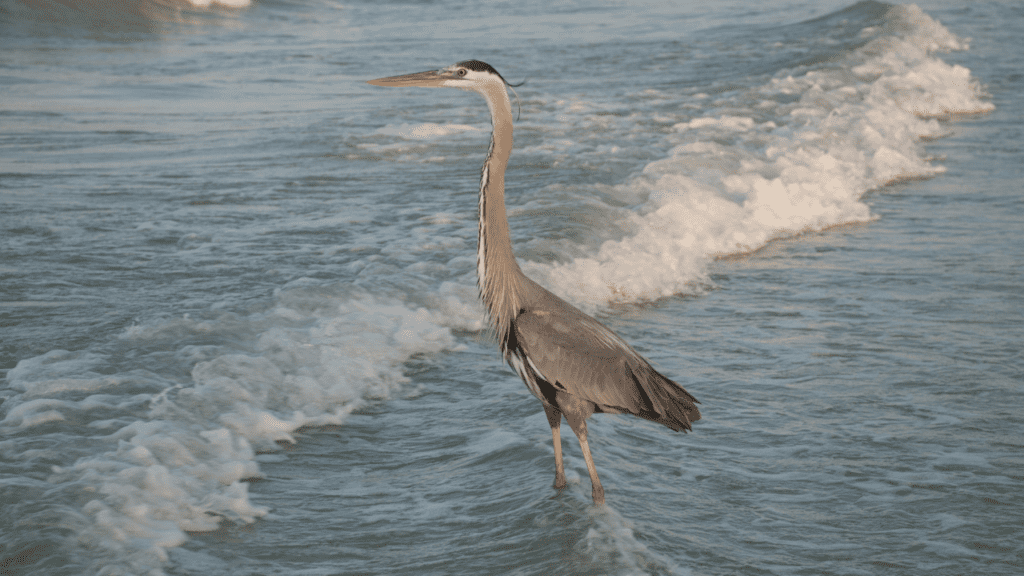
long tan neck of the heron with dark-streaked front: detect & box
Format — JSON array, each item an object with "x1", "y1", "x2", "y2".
[{"x1": 476, "y1": 80, "x2": 525, "y2": 342}]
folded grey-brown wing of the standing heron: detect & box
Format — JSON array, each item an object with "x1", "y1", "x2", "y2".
[{"x1": 512, "y1": 300, "x2": 700, "y2": 430}]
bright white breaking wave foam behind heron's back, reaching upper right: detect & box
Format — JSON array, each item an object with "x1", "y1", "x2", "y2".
[{"x1": 524, "y1": 5, "x2": 992, "y2": 308}]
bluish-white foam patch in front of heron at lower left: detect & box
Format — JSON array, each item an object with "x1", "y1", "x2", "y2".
[{"x1": 0, "y1": 289, "x2": 464, "y2": 574}]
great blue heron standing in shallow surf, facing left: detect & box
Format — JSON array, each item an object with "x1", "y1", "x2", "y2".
[{"x1": 369, "y1": 60, "x2": 700, "y2": 504}]
